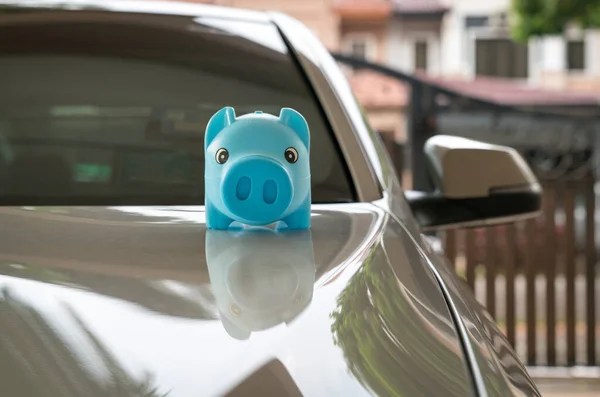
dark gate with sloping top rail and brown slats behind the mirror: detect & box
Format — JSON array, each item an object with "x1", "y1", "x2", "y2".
[{"x1": 334, "y1": 50, "x2": 600, "y2": 366}]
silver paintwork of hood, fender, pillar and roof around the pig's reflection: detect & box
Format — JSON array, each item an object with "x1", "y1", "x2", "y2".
[{"x1": 0, "y1": 1, "x2": 539, "y2": 396}]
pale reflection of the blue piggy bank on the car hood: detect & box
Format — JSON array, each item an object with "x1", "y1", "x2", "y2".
[{"x1": 206, "y1": 227, "x2": 315, "y2": 340}]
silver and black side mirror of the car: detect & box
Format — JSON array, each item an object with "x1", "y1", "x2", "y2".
[{"x1": 405, "y1": 135, "x2": 542, "y2": 231}]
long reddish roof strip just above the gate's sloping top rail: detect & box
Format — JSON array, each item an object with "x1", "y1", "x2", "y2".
[{"x1": 419, "y1": 74, "x2": 600, "y2": 106}]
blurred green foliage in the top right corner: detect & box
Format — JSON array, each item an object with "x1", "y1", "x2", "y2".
[{"x1": 512, "y1": 0, "x2": 600, "y2": 42}]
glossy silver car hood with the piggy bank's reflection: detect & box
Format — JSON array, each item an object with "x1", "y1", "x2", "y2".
[{"x1": 0, "y1": 204, "x2": 472, "y2": 397}]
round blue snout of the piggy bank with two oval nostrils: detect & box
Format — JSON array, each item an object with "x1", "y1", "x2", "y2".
[{"x1": 221, "y1": 156, "x2": 294, "y2": 223}]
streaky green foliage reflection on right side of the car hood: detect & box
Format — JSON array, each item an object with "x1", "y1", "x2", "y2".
[{"x1": 331, "y1": 244, "x2": 472, "y2": 396}]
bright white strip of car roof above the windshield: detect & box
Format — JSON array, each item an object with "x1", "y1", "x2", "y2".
[{"x1": 0, "y1": 0, "x2": 271, "y2": 22}]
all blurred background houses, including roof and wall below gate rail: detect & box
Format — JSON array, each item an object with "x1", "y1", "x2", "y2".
[{"x1": 171, "y1": 0, "x2": 600, "y2": 143}]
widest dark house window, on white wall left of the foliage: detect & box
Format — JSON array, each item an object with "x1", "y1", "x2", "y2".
[{"x1": 475, "y1": 38, "x2": 529, "y2": 79}]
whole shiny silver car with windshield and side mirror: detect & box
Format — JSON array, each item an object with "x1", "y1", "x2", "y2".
[{"x1": 0, "y1": 0, "x2": 540, "y2": 397}]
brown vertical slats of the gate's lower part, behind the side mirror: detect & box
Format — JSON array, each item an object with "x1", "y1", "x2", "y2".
[{"x1": 382, "y1": 137, "x2": 600, "y2": 366}]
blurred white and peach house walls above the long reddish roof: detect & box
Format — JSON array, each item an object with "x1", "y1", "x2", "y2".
[{"x1": 336, "y1": 0, "x2": 600, "y2": 90}]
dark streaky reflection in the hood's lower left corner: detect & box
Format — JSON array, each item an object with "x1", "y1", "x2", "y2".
[{"x1": 0, "y1": 286, "x2": 169, "y2": 397}]
